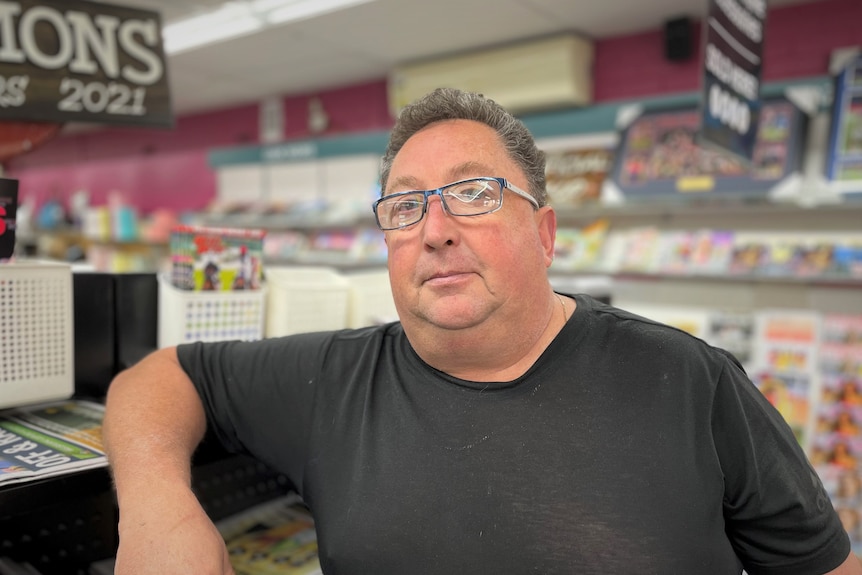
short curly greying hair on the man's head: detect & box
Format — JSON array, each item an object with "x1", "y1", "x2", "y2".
[{"x1": 380, "y1": 88, "x2": 548, "y2": 206}]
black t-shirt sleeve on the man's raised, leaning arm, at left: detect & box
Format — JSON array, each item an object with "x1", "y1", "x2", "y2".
[{"x1": 177, "y1": 333, "x2": 327, "y2": 486}]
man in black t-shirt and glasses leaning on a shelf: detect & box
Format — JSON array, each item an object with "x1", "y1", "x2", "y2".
[{"x1": 104, "y1": 89, "x2": 862, "y2": 575}]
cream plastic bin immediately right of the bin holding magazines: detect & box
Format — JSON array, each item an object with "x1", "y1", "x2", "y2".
[{"x1": 264, "y1": 266, "x2": 350, "y2": 337}]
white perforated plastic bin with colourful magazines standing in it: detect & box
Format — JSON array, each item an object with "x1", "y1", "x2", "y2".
[{"x1": 158, "y1": 274, "x2": 266, "y2": 348}]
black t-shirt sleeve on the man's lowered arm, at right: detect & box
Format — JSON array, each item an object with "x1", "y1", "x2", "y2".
[{"x1": 712, "y1": 360, "x2": 850, "y2": 575}]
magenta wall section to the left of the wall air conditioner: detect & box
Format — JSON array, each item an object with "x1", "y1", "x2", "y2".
[{"x1": 5, "y1": 80, "x2": 392, "y2": 214}]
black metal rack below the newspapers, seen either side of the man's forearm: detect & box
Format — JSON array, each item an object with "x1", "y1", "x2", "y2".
[{"x1": 0, "y1": 443, "x2": 291, "y2": 575}]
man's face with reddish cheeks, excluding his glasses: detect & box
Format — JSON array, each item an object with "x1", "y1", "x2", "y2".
[{"x1": 384, "y1": 120, "x2": 555, "y2": 330}]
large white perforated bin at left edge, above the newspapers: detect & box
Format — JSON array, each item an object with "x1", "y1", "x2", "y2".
[{"x1": 0, "y1": 260, "x2": 73, "y2": 408}]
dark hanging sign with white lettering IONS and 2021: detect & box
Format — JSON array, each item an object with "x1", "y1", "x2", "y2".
[{"x1": 0, "y1": 0, "x2": 173, "y2": 127}]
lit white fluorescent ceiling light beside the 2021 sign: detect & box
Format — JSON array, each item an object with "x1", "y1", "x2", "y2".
[{"x1": 162, "y1": 0, "x2": 373, "y2": 54}]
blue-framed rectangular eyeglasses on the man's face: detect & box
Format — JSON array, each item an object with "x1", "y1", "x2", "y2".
[{"x1": 372, "y1": 178, "x2": 539, "y2": 230}]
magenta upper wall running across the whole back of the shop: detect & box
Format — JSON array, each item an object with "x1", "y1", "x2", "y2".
[{"x1": 0, "y1": 0, "x2": 862, "y2": 213}]
